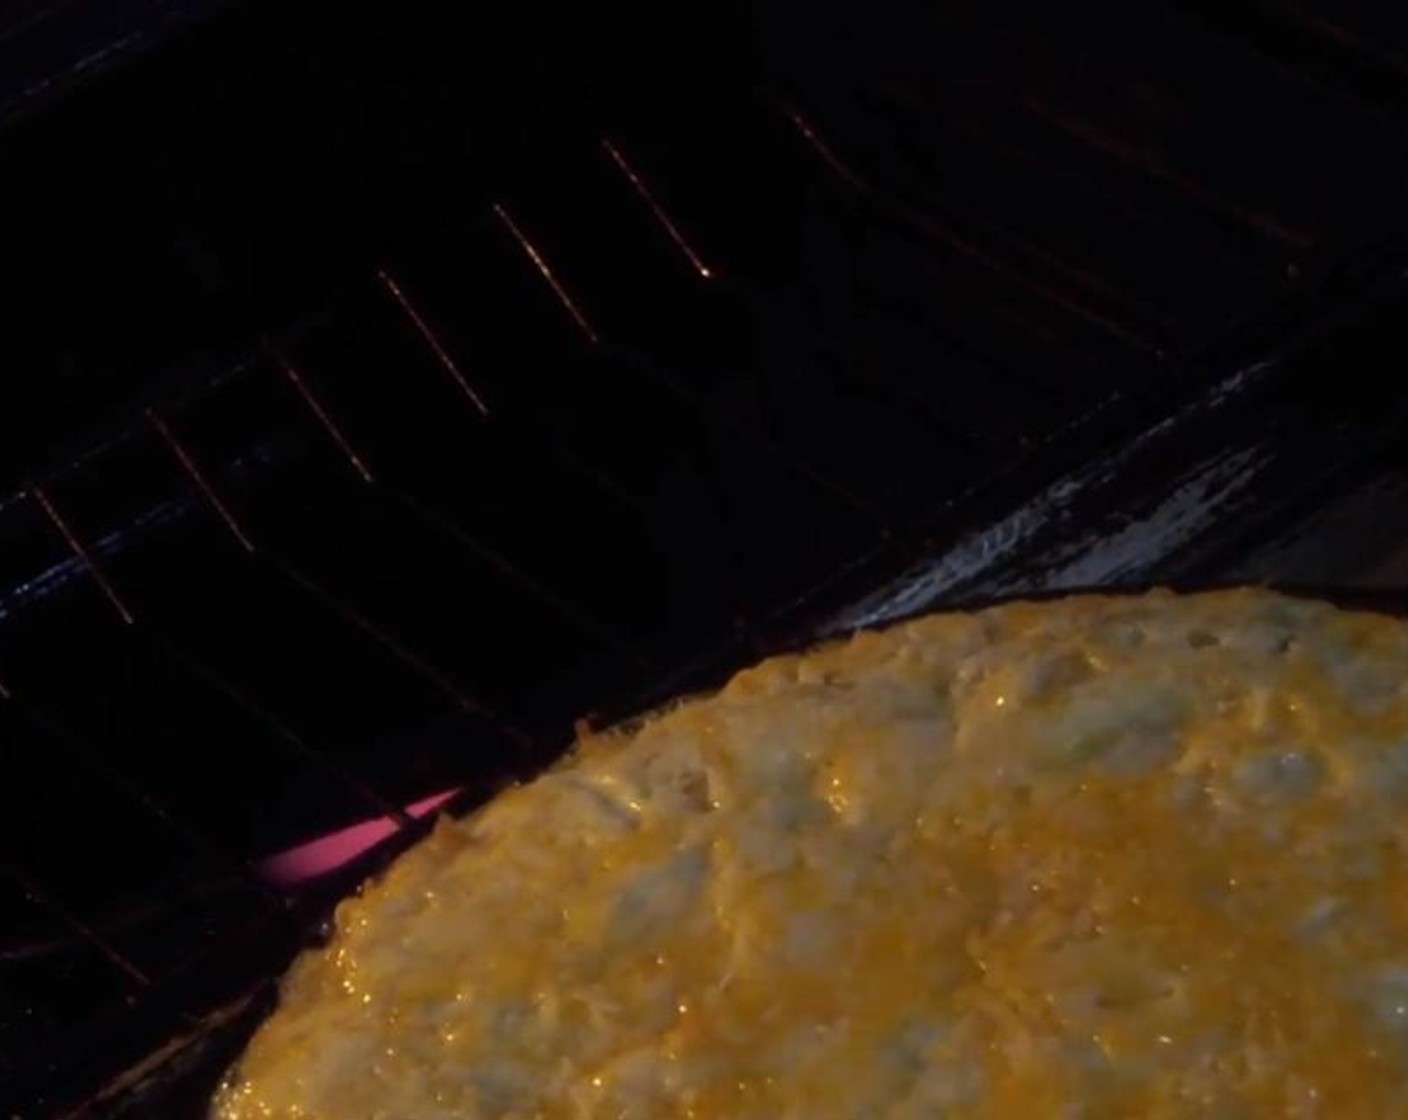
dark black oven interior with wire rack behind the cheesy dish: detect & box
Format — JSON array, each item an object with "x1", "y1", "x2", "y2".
[{"x1": 8, "y1": 0, "x2": 1408, "y2": 1120}]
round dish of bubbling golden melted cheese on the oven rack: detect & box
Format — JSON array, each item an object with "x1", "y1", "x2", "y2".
[{"x1": 214, "y1": 590, "x2": 1408, "y2": 1120}]
